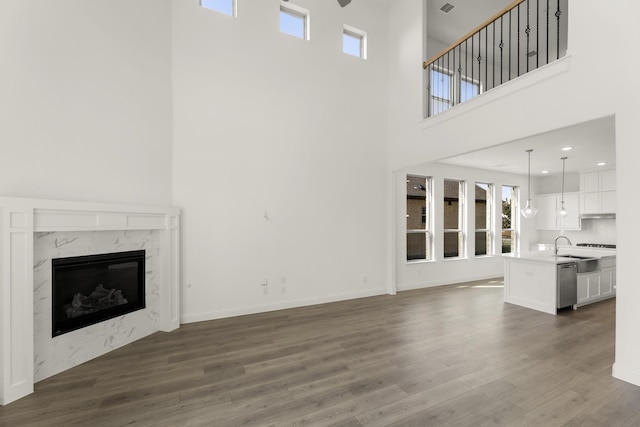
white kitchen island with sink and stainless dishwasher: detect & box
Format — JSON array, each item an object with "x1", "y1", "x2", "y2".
[{"x1": 504, "y1": 246, "x2": 615, "y2": 314}]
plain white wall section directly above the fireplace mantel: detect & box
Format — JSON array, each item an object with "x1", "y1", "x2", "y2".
[{"x1": 0, "y1": 0, "x2": 171, "y2": 205}]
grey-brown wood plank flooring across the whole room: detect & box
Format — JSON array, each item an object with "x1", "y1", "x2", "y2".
[{"x1": 0, "y1": 280, "x2": 640, "y2": 427}]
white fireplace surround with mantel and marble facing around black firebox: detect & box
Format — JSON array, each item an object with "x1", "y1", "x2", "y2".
[{"x1": 0, "y1": 197, "x2": 180, "y2": 405}]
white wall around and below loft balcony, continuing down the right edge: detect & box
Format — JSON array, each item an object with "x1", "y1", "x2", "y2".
[{"x1": 389, "y1": 0, "x2": 640, "y2": 384}]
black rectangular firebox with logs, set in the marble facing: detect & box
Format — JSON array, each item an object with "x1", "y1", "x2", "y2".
[{"x1": 51, "y1": 250, "x2": 145, "y2": 337}]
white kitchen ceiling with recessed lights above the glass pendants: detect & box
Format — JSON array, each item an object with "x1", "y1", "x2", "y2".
[{"x1": 438, "y1": 117, "x2": 616, "y2": 176}]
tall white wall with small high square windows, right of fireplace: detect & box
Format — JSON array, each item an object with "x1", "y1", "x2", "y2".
[{"x1": 173, "y1": 0, "x2": 390, "y2": 322}]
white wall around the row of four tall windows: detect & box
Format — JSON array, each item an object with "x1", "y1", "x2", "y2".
[{"x1": 396, "y1": 163, "x2": 537, "y2": 291}]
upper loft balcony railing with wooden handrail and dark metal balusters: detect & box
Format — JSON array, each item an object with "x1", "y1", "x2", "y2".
[{"x1": 423, "y1": 0, "x2": 568, "y2": 117}]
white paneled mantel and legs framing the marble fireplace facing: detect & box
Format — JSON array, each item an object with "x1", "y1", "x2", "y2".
[{"x1": 0, "y1": 197, "x2": 180, "y2": 405}]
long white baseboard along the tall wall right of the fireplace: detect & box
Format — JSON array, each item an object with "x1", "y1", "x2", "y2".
[{"x1": 180, "y1": 288, "x2": 388, "y2": 323}]
